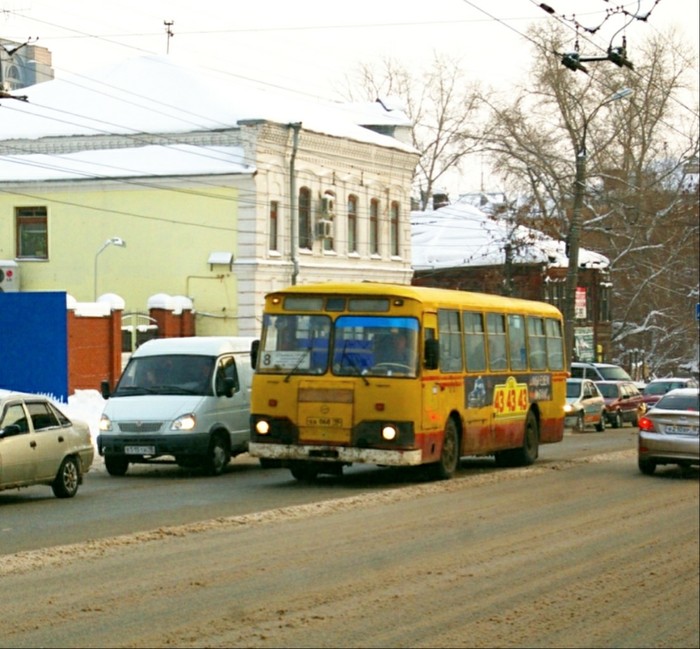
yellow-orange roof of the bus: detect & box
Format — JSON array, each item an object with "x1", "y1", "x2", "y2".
[{"x1": 267, "y1": 282, "x2": 561, "y2": 317}]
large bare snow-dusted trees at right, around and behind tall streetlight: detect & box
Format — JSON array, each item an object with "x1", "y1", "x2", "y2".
[{"x1": 486, "y1": 28, "x2": 699, "y2": 374}]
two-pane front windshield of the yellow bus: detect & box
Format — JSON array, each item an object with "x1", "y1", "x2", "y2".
[{"x1": 258, "y1": 314, "x2": 418, "y2": 377}]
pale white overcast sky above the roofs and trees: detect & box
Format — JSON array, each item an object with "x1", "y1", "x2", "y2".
[{"x1": 0, "y1": 0, "x2": 700, "y2": 99}]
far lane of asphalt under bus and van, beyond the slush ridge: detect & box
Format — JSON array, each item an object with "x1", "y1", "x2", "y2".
[{"x1": 0, "y1": 426, "x2": 637, "y2": 556}]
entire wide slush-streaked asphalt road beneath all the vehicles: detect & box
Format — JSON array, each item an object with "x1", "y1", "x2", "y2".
[{"x1": 0, "y1": 427, "x2": 700, "y2": 647}]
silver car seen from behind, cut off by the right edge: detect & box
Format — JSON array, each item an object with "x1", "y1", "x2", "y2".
[{"x1": 637, "y1": 388, "x2": 700, "y2": 475}]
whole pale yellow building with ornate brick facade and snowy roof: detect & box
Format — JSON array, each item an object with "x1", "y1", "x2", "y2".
[{"x1": 0, "y1": 56, "x2": 418, "y2": 335}]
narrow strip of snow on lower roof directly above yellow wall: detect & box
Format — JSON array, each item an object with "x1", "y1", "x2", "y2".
[{"x1": 0, "y1": 144, "x2": 255, "y2": 182}]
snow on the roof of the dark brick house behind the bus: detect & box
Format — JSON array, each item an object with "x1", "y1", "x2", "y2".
[{"x1": 411, "y1": 203, "x2": 610, "y2": 270}]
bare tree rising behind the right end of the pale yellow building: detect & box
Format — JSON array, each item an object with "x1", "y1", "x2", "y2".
[{"x1": 345, "y1": 54, "x2": 483, "y2": 209}]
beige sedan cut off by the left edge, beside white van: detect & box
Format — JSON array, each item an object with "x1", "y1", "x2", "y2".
[{"x1": 0, "y1": 392, "x2": 95, "y2": 498}]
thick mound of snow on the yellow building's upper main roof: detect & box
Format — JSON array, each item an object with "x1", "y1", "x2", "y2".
[{"x1": 0, "y1": 55, "x2": 415, "y2": 152}]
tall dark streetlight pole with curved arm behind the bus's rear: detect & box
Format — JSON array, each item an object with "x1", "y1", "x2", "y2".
[{"x1": 564, "y1": 88, "x2": 634, "y2": 367}]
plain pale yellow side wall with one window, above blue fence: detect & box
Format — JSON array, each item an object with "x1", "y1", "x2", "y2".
[{"x1": 0, "y1": 179, "x2": 239, "y2": 332}]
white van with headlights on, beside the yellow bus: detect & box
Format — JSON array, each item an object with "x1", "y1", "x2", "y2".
[{"x1": 97, "y1": 336, "x2": 253, "y2": 476}]
